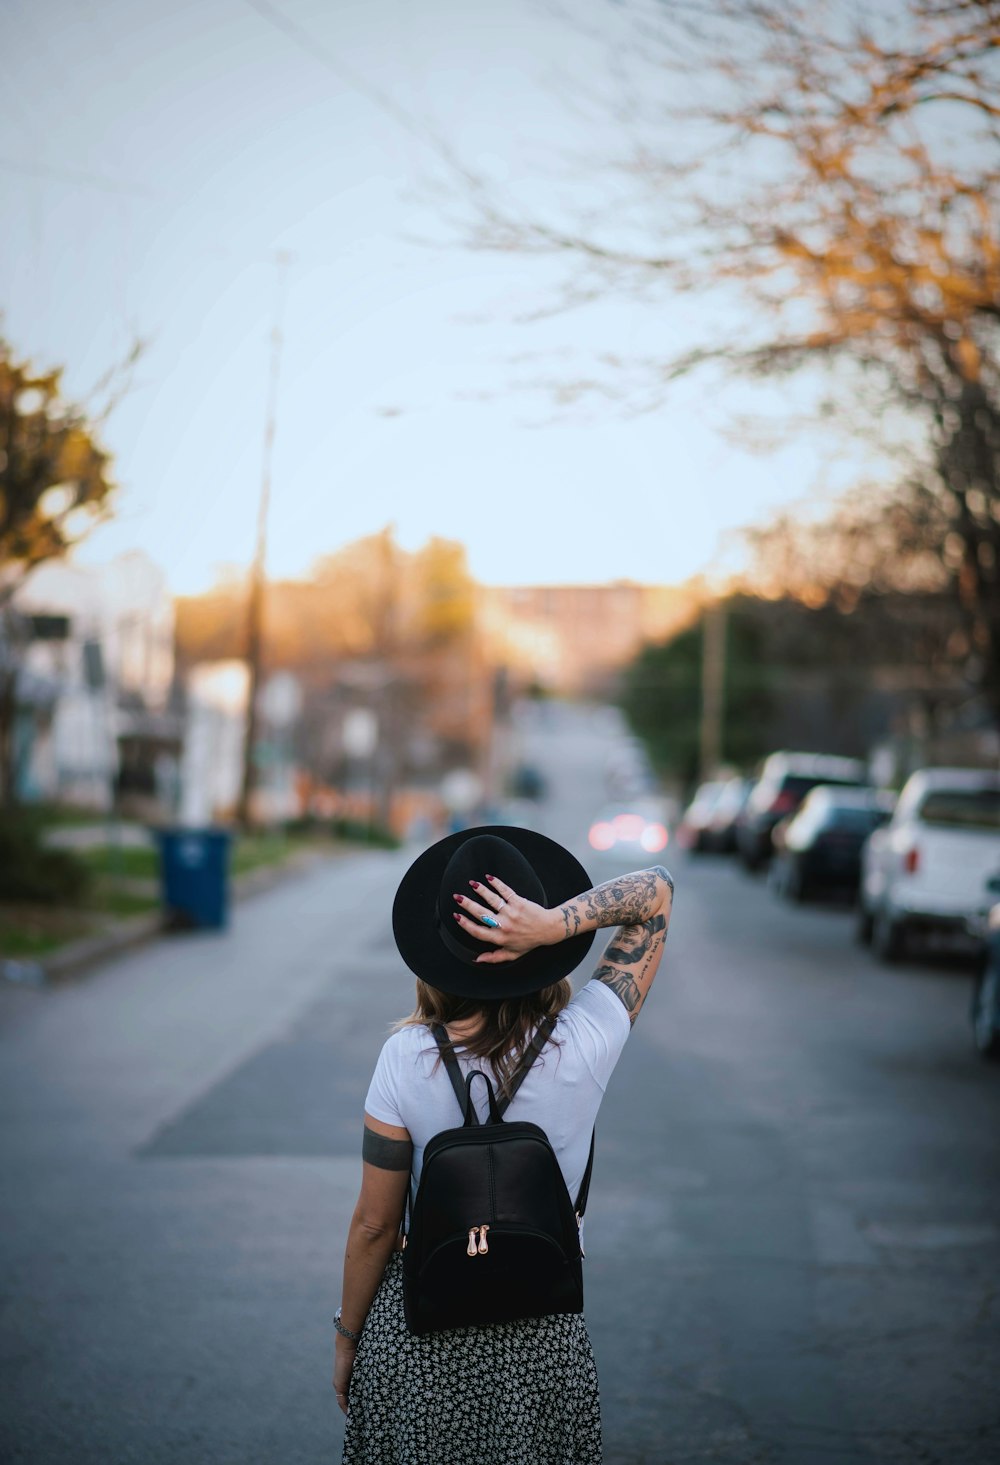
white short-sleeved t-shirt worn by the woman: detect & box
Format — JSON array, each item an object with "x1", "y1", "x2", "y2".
[{"x1": 365, "y1": 980, "x2": 631, "y2": 1203}]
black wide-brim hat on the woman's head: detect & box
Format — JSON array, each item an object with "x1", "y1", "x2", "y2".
[{"x1": 392, "y1": 825, "x2": 594, "y2": 1001}]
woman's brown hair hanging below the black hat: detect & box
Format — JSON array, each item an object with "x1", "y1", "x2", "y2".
[{"x1": 394, "y1": 977, "x2": 572, "y2": 1093}]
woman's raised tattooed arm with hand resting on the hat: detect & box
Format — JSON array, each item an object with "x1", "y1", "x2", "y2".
[{"x1": 455, "y1": 864, "x2": 673, "y2": 1023}]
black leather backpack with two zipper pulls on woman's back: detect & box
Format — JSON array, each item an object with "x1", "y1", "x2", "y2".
[{"x1": 403, "y1": 1020, "x2": 594, "y2": 1333}]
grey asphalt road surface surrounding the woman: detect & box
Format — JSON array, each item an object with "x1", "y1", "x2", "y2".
[{"x1": 0, "y1": 708, "x2": 1000, "y2": 1465}]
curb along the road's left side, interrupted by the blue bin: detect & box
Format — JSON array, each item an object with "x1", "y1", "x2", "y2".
[{"x1": 7, "y1": 848, "x2": 361, "y2": 987}]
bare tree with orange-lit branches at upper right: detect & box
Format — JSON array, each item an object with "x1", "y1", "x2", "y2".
[{"x1": 467, "y1": 0, "x2": 1000, "y2": 724}]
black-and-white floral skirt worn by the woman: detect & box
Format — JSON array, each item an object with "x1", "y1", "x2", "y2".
[{"x1": 343, "y1": 1253, "x2": 602, "y2": 1465}]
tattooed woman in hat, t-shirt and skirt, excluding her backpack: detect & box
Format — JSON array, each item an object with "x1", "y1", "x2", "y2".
[{"x1": 334, "y1": 826, "x2": 673, "y2": 1465}]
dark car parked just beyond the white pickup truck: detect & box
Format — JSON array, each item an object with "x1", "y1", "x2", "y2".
[{"x1": 772, "y1": 784, "x2": 896, "y2": 901}]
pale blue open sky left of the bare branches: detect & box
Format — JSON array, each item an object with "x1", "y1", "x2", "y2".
[{"x1": 0, "y1": 0, "x2": 890, "y2": 593}]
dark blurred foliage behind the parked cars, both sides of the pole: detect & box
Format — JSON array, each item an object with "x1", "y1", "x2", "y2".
[{"x1": 622, "y1": 586, "x2": 968, "y2": 784}]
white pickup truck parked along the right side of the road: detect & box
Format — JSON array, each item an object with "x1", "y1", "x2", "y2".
[{"x1": 858, "y1": 768, "x2": 1000, "y2": 961}]
